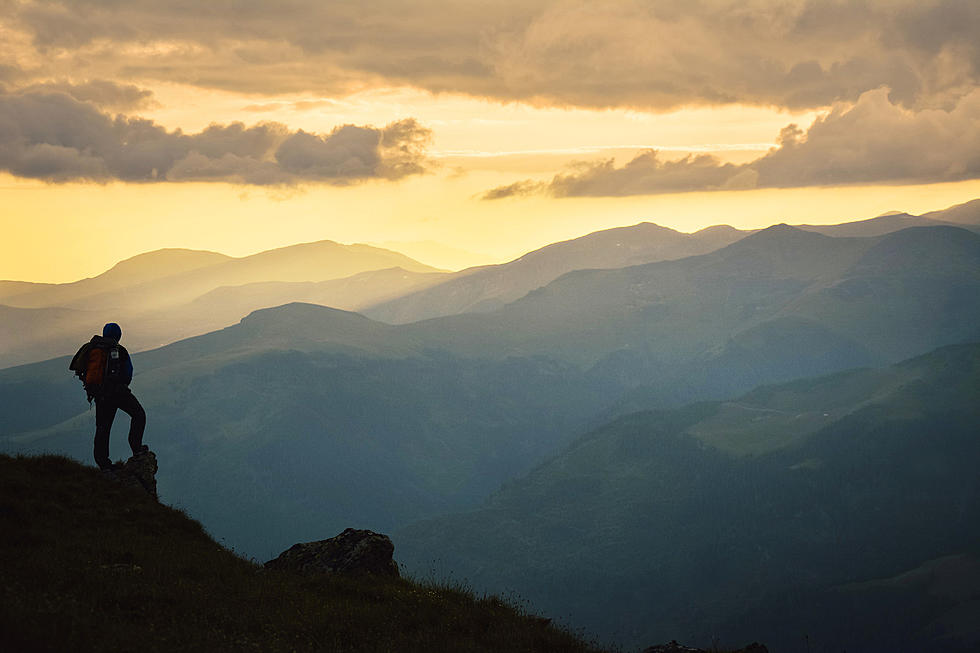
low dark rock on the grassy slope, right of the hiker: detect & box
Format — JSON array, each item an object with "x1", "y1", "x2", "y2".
[{"x1": 265, "y1": 528, "x2": 399, "y2": 577}]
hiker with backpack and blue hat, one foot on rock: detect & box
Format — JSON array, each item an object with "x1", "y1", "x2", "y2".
[{"x1": 68, "y1": 322, "x2": 149, "y2": 471}]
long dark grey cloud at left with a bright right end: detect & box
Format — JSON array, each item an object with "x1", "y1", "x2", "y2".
[{"x1": 0, "y1": 88, "x2": 430, "y2": 185}]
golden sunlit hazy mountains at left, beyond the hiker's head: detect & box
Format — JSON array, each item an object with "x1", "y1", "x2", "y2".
[{"x1": 0, "y1": 241, "x2": 442, "y2": 366}]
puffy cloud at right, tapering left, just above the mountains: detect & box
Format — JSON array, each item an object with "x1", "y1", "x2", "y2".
[{"x1": 482, "y1": 88, "x2": 980, "y2": 199}]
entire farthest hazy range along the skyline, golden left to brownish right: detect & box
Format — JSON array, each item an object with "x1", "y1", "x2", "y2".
[{"x1": 0, "y1": 200, "x2": 980, "y2": 367}]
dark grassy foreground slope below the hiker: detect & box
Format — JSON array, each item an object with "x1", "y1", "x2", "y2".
[{"x1": 0, "y1": 456, "x2": 596, "y2": 653}]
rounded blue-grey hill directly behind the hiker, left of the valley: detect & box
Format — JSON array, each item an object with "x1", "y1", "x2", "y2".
[{"x1": 0, "y1": 304, "x2": 618, "y2": 555}]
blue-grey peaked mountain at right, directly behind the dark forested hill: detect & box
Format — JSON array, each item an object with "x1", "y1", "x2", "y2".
[{"x1": 422, "y1": 225, "x2": 980, "y2": 392}]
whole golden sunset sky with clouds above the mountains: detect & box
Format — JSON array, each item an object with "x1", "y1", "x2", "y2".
[{"x1": 0, "y1": 0, "x2": 980, "y2": 282}]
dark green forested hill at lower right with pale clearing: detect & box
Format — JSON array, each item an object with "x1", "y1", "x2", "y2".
[{"x1": 398, "y1": 344, "x2": 980, "y2": 653}]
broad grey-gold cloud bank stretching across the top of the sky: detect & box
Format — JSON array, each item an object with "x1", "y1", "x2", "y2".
[{"x1": 0, "y1": 0, "x2": 980, "y2": 110}]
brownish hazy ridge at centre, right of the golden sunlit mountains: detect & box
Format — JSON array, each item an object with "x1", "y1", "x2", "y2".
[{"x1": 364, "y1": 222, "x2": 744, "y2": 324}]
